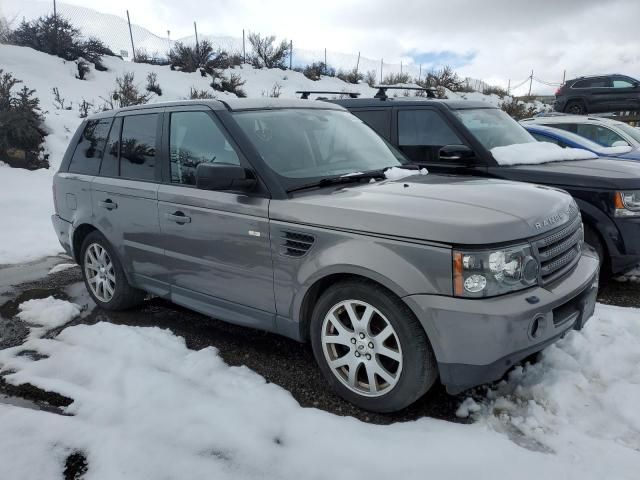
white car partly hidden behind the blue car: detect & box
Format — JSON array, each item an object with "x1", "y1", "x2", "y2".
[{"x1": 520, "y1": 115, "x2": 640, "y2": 148}]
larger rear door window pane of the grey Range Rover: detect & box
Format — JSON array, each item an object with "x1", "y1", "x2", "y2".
[{"x1": 120, "y1": 113, "x2": 159, "y2": 180}]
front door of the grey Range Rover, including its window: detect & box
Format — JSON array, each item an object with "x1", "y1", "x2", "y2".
[{"x1": 158, "y1": 106, "x2": 275, "y2": 330}]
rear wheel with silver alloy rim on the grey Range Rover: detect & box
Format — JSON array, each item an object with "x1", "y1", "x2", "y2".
[{"x1": 80, "y1": 231, "x2": 146, "y2": 310}]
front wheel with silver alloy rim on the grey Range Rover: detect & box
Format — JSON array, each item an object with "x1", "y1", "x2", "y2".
[{"x1": 310, "y1": 280, "x2": 438, "y2": 412}]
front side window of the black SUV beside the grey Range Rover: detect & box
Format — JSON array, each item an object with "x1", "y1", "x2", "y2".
[{"x1": 398, "y1": 109, "x2": 464, "y2": 162}]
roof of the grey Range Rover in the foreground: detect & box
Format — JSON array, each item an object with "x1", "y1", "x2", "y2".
[{"x1": 89, "y1": 98, "x2": 342, "y2": 120}]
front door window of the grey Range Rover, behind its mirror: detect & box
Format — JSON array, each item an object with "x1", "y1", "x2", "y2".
[{"x1": 169, "y1": 112, "x2": 240, "y2": 185}]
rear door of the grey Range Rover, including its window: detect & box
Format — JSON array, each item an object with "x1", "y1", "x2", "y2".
[{"x1": 92, "y1": 109, "x2": 169, "y2": 296}]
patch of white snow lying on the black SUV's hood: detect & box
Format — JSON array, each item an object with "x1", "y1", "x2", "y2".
[{"x1": 491, "y1": 142, "x2": 598, "y2": 165}]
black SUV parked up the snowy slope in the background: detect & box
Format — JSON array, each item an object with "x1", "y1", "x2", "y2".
[{"x1": 554, "y1": 75, "x2": 640, "y2": 115}]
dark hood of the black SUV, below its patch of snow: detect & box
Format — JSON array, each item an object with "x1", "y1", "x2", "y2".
[{"x1": 498, "y1": 158, "x2": 640, "y2": 190}]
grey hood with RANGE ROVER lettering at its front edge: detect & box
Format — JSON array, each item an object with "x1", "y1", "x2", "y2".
[{"x1": 269, "y1": 175, "x2": 577, "y2": 245}]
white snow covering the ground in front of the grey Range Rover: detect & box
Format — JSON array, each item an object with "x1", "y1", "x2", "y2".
[{"x1": 0, "y1": 299, "x2": 640, "y2": 480}]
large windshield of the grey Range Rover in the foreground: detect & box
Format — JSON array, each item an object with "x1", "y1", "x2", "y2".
[{"x1": 234, "y1": 109, "x2": 407, "y2": 188}]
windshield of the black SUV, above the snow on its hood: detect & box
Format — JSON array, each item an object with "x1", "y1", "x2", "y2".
[{"x1": 455, "y1": 108, "x2": 536, "y2": 150}]
